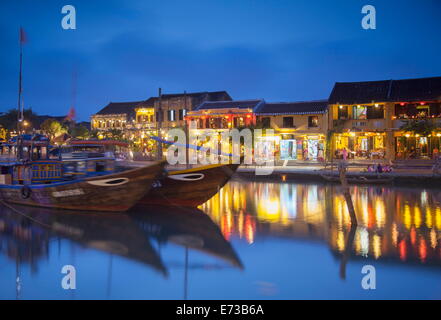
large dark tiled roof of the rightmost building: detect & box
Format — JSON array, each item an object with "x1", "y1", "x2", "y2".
[{"x1": 329, "y1": 77, "x2": 441, "y2": 104}]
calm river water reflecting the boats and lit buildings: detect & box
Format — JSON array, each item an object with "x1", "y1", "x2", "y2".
[{"x1": 0, "y1": 179, "x2": 441, "y2": 299}]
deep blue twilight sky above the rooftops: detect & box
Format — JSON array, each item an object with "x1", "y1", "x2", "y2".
[{"x1": 0, "y1": 0, "x2": 441, "y2": 120}]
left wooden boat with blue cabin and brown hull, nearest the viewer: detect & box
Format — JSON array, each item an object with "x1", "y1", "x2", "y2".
[{"x1": 0, "y1": 137, "x2": 165, "y2": 211}]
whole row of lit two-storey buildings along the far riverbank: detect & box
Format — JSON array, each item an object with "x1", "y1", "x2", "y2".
[{"x1": 91, "y1": 77, "x2": 441, "y2": 161}]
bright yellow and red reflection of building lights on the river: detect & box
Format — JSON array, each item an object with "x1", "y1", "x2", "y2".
[{"x1": 201, "y1": 181, "x2": 441, "y2": 265}]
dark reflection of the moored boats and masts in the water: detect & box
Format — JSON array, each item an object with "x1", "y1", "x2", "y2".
[{"x1": 0, "y1": 204, "x2": 243, "y2": 299}]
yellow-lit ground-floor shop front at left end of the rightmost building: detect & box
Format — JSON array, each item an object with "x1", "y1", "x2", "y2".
[{"x1": 334, "y1": 132, "x2": 386, "y2": 160}]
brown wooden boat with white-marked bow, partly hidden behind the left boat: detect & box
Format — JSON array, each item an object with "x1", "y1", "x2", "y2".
[{"x1": 139, "y1": 164, "x2": 240, "y2": 207}]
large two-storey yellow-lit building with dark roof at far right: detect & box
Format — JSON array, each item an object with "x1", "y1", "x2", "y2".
[{"x1": 329, "y1": 77, "x2": 441, "y2": 160}]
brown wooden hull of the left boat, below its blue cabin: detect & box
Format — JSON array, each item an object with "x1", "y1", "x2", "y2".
[{"x1": 0, "y1": 162, "x2": 164, "y2": 212}]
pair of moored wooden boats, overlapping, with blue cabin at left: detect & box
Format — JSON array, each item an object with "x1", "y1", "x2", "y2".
[{"x1": 0, "y1": 136, "x2": 239, "y2": 212}]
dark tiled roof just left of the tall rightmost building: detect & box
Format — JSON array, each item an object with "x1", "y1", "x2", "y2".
[{"x1": 255, "y1": 100, "x2": 328, "y2": 115}]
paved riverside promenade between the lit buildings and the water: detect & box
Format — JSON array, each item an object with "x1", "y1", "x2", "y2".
[{"x1": 121, "y1": 160, "x2": 441, "y2": 188}]
